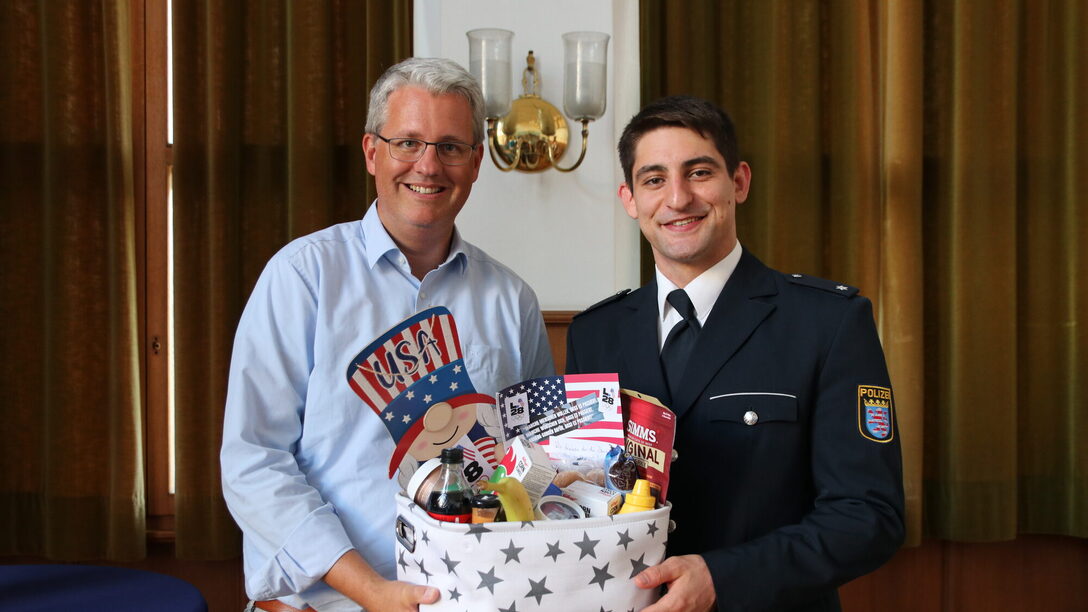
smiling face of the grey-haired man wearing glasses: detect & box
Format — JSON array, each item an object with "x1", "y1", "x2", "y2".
[{"x1": 362, "y1": 86, "x2": 483, "y2": 242}]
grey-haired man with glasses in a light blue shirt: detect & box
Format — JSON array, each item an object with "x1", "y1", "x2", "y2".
[{"x1": 221, "y1": 59, "x2": 554, "y2": 612}]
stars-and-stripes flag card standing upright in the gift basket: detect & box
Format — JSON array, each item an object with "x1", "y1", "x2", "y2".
[{"x1": 498, "y1": 374, "x2": 623, "y2": 445}]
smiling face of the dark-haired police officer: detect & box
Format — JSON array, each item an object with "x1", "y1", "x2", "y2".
[{"x1": 619, "y1": 127, "x2": 752, "y2": 286}]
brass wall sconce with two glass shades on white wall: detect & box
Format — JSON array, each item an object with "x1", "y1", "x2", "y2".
[{"x1": 468, "y1": 28, "x2": 609, "y2": 172}]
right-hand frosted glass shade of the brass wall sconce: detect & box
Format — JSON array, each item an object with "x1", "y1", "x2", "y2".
[{"x1": 562, "y1": 32, "x2": 609, "y2": 121}]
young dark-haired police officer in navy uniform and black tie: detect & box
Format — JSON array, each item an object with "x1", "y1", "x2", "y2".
[{"x1": 567, "y1": 97, "x2": 904, "y2": 612}]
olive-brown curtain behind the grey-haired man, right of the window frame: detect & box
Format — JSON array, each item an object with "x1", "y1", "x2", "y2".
[{"x1": 173, "y1": 0, "x2": 411, "y2": 559}]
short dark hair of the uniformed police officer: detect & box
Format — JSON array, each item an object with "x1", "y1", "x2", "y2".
[{"x1": 618, "y1": 96, "x2": 741, "y2": 187}]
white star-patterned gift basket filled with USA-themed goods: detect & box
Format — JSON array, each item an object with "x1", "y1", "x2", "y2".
[{"x1": 347, "y1": 307, "x2": 676, "y2": 612}]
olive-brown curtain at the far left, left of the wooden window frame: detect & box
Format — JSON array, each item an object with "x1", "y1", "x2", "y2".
[{"x1": 0, "y1": 0, "x2": 146, "y2": 560}]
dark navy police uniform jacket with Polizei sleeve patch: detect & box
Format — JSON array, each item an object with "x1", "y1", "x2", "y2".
[{"x1": 567, "y1": 250, "x2": 904, "y2": 611}]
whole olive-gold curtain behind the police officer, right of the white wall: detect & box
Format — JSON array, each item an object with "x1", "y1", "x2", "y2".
[{"x1": 640, "y1": 0, "x2": 1088, "y2": 543}]
